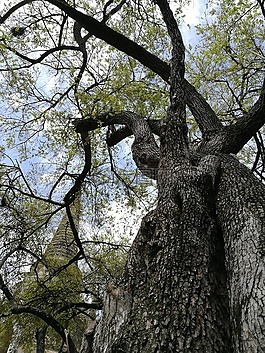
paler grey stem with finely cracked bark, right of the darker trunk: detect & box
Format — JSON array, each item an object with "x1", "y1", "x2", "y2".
[{"x1": 216, "y1": 156, "x2": 265, "y2": 353}]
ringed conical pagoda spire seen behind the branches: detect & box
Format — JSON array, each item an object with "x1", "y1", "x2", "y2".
[{"x1": 7, "y1": 191, "x2": 82, "y2": 353}]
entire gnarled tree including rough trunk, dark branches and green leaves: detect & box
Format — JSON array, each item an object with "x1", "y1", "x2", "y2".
[{"x1": 1, "y1": 0, "x2": 265, "y2": 353}]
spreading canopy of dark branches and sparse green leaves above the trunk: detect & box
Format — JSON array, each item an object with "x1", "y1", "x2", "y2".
[{"x1": 0, "y1": 0, "x2": 265, "y2": 351}]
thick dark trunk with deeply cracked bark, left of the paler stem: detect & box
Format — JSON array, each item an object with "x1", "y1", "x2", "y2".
[{"x1": 94, "y1": 157, "x2": 233, "y2": 353}]
